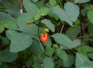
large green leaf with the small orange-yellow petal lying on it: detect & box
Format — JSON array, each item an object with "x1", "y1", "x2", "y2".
[{"x1": 17, "y1": 13, "x2": 38, "y2": 35}]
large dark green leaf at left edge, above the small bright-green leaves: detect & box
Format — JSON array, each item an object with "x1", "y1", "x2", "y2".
[{"x1": 0, "y1": 12, "x2": 17, "y2": 22}]
